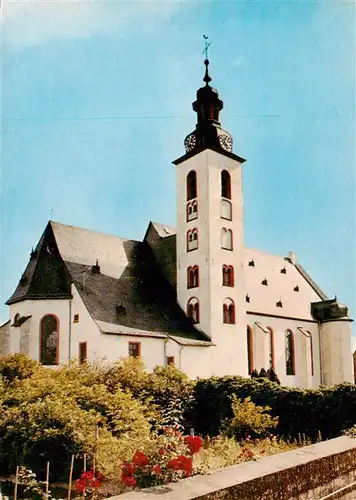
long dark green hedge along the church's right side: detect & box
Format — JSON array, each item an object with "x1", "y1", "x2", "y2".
[{"x1": 187, "y1": 376, "x2": 356, "y2": 441}]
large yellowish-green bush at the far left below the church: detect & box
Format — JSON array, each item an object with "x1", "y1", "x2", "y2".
[{"x1": 0, "y1": 358, "x2": 150, "y2": 480}]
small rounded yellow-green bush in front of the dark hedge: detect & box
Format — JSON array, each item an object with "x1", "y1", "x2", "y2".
[{"x1": 222, "y1": 394, "x2": 278, "y2": 440}]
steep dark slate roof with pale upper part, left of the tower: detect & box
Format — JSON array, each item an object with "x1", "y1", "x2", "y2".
[{"x1": 7, "y1": 221, "x2": 211, "y2": 345}]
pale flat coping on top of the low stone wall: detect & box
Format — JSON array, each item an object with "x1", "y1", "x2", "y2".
[{"x1": 110, "y1": 436, "x2": 356, "y2": 500}]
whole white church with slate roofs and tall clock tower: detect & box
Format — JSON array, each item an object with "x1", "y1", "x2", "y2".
[{"x1": 0, "y1": 60, "x2": 353, "y2": 388}]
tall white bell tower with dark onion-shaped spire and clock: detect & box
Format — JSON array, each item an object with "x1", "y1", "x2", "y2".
[{"x1": 173, "y1": 59, "x2": 247, "y2": 375}]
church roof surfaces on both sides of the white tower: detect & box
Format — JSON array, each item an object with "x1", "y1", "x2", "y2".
[{"x1": 8, "y1": 221, "x2": 326, "y2": 336}]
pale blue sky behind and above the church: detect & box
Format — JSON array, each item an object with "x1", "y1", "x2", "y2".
[{"x1": 0, "y1": 0, "x2": 356, "y2": 328}]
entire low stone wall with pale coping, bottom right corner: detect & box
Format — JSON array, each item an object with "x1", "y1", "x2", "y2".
[{"x1": 112, "y1": 436, "x2": 356, "y2": 500}]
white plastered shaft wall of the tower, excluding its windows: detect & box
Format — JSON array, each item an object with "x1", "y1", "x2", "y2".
[{"x1": 177, "y1": 150, "x2": 247, "y2": 375}]
